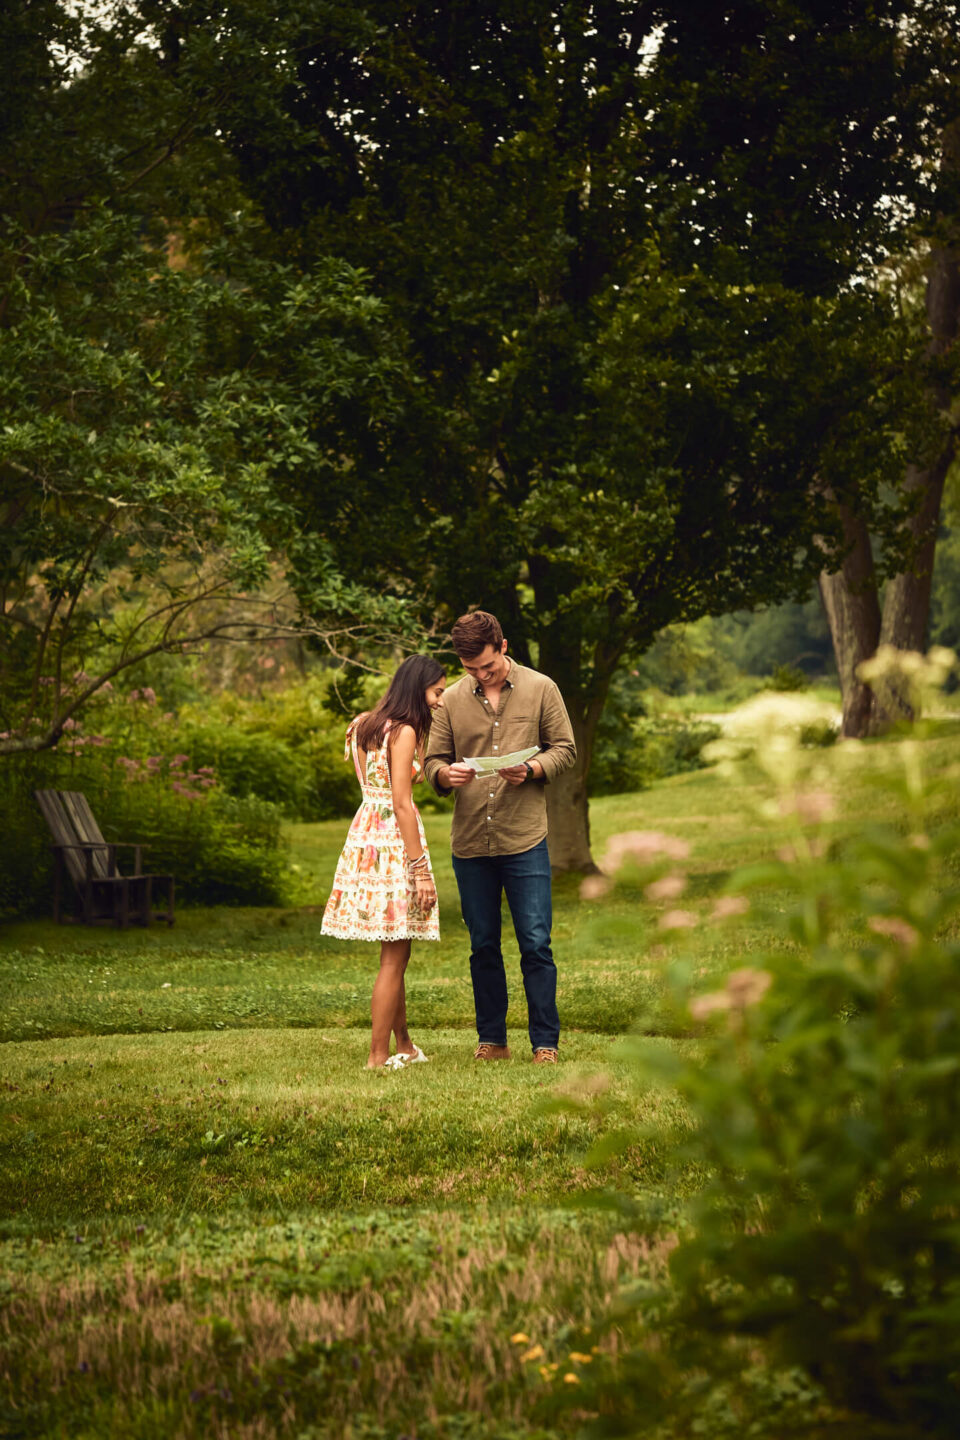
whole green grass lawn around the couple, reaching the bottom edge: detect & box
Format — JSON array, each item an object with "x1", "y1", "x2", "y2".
[{"x1": 0, "y1": 730, "x2": 957, "y2": 1440}]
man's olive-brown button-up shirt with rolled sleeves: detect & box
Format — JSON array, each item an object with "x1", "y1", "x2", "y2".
[{"x1": 425, "y1": 660, "x2": 577, "y2": 860}]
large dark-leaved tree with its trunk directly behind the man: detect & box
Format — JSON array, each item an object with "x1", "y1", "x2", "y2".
[{"x1": 164, "y1": 0, "x2": 936, "y2": 865}]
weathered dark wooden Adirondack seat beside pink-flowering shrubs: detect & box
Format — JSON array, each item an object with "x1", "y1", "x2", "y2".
[{"x1": 35, "y1": 791, "x2": 174, "y2": 927}]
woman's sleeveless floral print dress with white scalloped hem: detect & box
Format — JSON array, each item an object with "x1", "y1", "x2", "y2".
[{"x1": 320, "y1": 717, "x2": 440, "y2": 940}]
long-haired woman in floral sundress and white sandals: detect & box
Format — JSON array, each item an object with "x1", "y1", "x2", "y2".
[{"x1": 321, "y1": 655, "x2": 446, "y2": 1070}]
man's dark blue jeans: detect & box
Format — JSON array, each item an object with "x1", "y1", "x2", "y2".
[{"x1": 453, "y1": 840, "x2": 560, "y2": 1050}]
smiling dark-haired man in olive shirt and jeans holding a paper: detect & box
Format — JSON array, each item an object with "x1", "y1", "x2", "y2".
[{"x1": 426, "y1": 611, "x2": 577, "y2": 1064}]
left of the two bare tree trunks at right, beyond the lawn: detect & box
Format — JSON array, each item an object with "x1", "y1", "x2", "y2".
[{"x1": 820, "y1": 504, "x2": 879, "y2": 739}]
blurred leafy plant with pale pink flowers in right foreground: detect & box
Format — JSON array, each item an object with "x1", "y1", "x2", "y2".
[{"x1": 544, "y1": 649, "x2": 960, "y2": 1440}]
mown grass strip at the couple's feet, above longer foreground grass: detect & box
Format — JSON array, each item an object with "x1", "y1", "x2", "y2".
[{"x1": 0, "y1": 1030, "x2": 693, "y2": 1234}]
